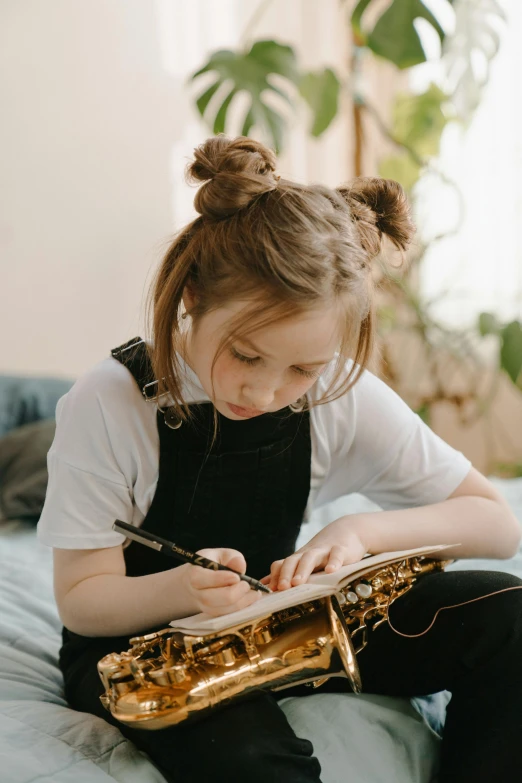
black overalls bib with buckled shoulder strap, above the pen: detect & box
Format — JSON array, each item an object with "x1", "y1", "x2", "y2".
[{"x1": 113, "y1": 343, "x2": 311, "y2": 579}]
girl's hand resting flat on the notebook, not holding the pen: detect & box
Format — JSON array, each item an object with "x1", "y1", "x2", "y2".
[{"x1": 261, "y1": 525, "x2": 367, "y2": 590}]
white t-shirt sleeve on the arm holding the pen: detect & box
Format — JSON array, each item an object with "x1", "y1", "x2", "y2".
[{"x1": 38, "y1": 365, "x2": 143, "y2": 549}]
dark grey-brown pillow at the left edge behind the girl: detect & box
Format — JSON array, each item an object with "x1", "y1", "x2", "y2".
[{"x1": 0, "y1": 419, "x2": 55, "y2": 524}]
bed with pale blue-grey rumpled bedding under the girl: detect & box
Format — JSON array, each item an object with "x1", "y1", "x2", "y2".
[{"x1": 0, "y1": 378, "x2": 522, "y2": 783}]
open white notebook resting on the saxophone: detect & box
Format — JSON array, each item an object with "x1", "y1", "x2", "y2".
[{"x1": 170, "y1": 544, "x2": 456, "y2": 636}]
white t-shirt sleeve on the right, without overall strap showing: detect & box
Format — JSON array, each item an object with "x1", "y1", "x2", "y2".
[{"x1": 320, "y1": 371, "x2": 471, "y2": 510}]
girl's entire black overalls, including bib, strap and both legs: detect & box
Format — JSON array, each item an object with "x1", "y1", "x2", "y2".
[{"x1": 60, "y1": 341, "x2": 522, "y2": 783}]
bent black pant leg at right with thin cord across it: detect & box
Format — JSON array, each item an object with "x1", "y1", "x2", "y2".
[{"x1": 358, "y1": 571, "x2": 522, "y2": 783}]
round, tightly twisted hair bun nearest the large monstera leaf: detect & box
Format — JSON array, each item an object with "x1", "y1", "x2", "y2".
[{"x1": 187, "y1": 135, "x2": 279, "y2": 219}]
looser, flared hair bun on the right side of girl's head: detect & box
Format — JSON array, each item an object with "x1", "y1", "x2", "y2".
[{"x1": 337, "y1": 177, "x2": 415, "y2": 256}]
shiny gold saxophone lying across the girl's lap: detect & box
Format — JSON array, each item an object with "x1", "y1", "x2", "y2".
[{"x1": 98, "y1": 556, "x2": 446, "y2": 729}]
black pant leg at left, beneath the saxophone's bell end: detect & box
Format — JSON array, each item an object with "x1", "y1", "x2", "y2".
[{"x1": 64, "y1": 639, "x2": 321, "y2": 783}]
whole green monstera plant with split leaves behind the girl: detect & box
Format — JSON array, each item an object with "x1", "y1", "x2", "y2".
[{"x1": 190, "y1": 0, "x2": 522, "y2": 472}]
